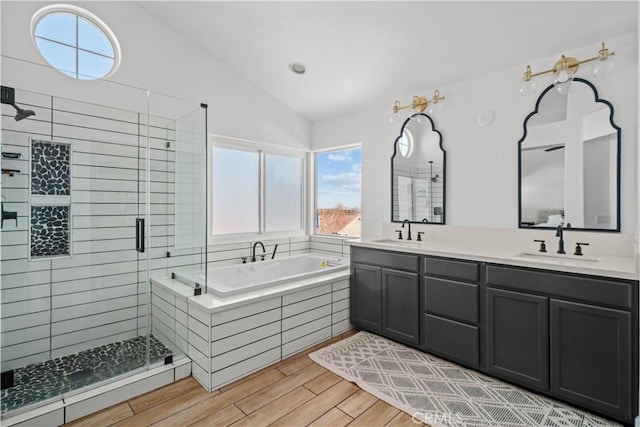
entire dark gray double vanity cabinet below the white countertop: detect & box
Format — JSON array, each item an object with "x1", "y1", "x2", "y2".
[{"x1": 350, "y1": 246, "x2": 638, "y2": 423}]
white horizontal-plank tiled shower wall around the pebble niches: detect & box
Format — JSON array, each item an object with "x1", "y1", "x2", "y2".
[{"x1": 1, "y1": 89, "x2": 206, "y2": 418}]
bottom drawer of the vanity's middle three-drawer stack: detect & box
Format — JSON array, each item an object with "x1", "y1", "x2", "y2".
[{"x1": 423, "y1": 314, "x2": 480, "y2": 366}]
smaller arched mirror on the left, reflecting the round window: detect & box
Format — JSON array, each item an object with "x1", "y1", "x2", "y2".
[{"x1": 391, "y1": 113, "x2": 446, "y2": 224}]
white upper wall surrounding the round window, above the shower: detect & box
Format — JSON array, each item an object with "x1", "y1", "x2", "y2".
[{"x1": 0, "y1": 1, "x2": 310, "y2": 148}]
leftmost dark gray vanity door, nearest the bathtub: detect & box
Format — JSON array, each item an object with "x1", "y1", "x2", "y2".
[{"x1": 351, "y1": 263, "x2": 382, "y2": 332}]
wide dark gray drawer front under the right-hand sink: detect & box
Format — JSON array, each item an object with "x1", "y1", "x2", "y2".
[{"x1": 487, "y1": 265, "x2": 633, "y2": 310}]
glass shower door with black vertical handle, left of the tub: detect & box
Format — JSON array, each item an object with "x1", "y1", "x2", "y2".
[{"x1": 0, "y1": 88, "x2": 159, "y2": 415}]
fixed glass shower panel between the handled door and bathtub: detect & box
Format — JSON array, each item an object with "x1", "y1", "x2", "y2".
[{"x1": 146, "y1": 93, "x2": 207, "y2": 360}]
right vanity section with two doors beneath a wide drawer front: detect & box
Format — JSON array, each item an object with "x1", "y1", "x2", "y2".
[{"x1": 486, "y1": 265, "x2": 638, "y2": 421}]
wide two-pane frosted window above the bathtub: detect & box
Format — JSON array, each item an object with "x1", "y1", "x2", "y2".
[{"x1": 210, "y1": 144, "x2": 305, "y2": 236}]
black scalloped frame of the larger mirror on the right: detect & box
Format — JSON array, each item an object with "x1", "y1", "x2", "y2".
[{"x1": 518, "y1": 77, "x2": 622, "y2": 233}]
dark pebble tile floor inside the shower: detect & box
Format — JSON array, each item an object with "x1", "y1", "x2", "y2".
[{"x1": 0, "y1": 335, "x2": 171, "y2": 414}]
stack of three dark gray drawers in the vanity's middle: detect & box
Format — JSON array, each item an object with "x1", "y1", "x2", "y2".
[{"x1": 421, "y1": 257, "x2": 480, "y2": 368}]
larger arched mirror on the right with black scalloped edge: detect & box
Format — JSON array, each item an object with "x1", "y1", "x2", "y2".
[{"x1": 518, "y1": 78, "x2": 620, "y2": 231}]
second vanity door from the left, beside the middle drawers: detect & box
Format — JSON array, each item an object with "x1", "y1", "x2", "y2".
[{"x1": 382, "y1": 268, "x2": 420, "y2": 345}]
